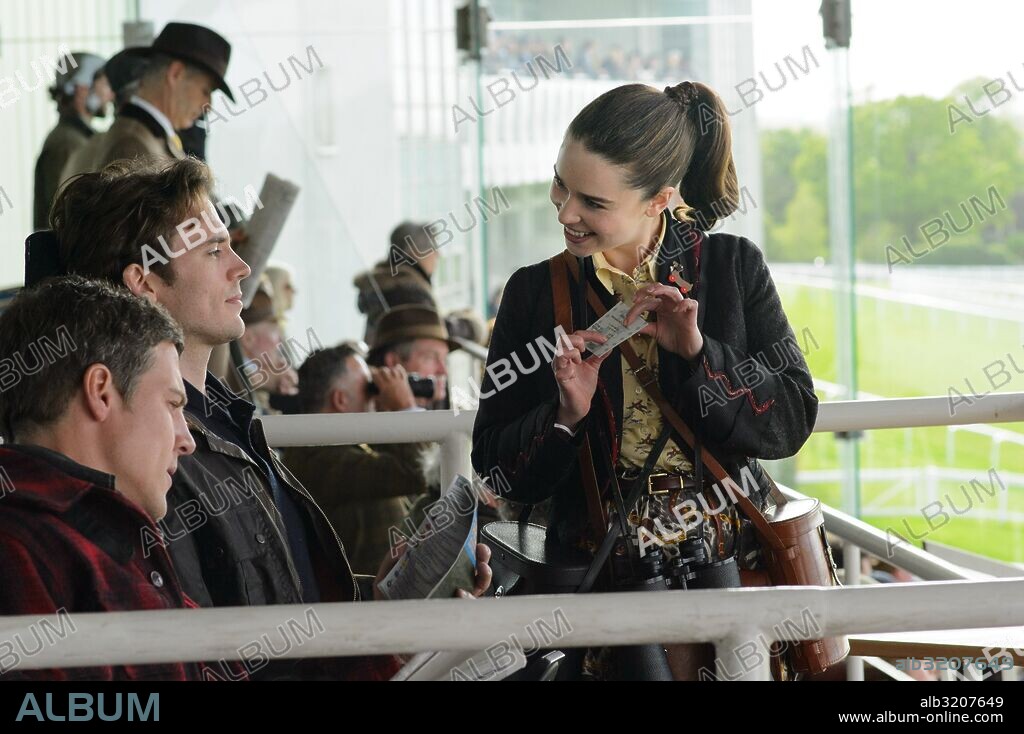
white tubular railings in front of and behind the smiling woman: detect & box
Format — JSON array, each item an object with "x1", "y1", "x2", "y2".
[{"x1": 0, "y1": 393, "x2": 1024, "y2": 680}]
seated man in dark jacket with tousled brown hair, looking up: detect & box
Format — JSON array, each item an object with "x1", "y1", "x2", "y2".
[{"x1": 52, "y1": 159, "x2": 490, "y2": 679}]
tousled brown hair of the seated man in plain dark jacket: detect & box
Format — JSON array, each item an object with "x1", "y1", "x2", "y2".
[{"x1": 50, "y1": 158, "x2": 217, "y2": 286}]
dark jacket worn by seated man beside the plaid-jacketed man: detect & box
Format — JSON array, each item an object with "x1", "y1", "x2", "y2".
[{"x1": 161, "y1": 375, "x2": 399, "y2": 680}]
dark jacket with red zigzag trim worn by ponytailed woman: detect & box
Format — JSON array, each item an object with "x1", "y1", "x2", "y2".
[{"x1": 473, "y1": 218, "x2": 818, "y2": 546}]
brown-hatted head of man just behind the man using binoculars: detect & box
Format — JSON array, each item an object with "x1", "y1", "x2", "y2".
[{"x1": 367, "y1": 305, "x2": 460, "y2": 407}]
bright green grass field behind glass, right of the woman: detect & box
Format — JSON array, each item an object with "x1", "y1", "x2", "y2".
[{"x1": 778, "y1": 284, "x2": 1024, "y2": 562}]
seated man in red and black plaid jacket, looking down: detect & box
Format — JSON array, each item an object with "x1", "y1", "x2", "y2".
[{"x1": 0, "y1": 277, "x2": 202, "y2": 681}]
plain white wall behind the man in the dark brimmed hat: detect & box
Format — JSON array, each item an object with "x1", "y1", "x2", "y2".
[{"x1": 140, "y1": 0, "x2": 399, "y2": 346}]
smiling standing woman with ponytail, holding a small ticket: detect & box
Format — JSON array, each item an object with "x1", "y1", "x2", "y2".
[{"x1": 473, "y1": 82, "x2": 817, "y2": 679}]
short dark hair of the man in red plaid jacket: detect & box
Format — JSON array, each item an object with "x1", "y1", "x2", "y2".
[{"x1": 0, "y1": 275, "x2": 184, "y2": 442}]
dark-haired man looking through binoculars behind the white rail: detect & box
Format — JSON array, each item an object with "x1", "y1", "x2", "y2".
[{"x1": 283, "y1": 346, "x2": 427, "y2": 573}]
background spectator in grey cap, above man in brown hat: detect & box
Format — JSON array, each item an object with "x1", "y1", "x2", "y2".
[{"x1": 353, "y1": 222, "x2": 440, "y2": 344}]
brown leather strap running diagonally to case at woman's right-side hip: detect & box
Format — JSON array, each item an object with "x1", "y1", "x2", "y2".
[{"x1": 562, "y1": 251, "x2": 785, "y2": 550}]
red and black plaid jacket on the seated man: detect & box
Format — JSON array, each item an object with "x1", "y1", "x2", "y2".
[{"x1": 0, "y1": 445, "x2": 245, "y2": 681}]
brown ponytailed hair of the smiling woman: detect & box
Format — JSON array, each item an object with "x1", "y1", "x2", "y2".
[{"x1": 568, "y1": 82, "x2": 739, "y2": 230}]
